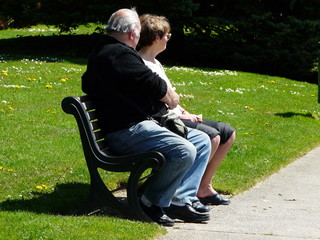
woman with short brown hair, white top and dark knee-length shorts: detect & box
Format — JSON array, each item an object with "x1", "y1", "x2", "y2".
[{"x1": 139, "y1": 14, "x2": 235, "y2": 212}]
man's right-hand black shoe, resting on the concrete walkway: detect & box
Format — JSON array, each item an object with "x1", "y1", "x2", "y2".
[{"x1": 163, "y1": 204, "x2": 210, "y2": 223}]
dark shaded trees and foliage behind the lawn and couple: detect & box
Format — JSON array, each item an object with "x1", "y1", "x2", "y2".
[{"x1": 0, "y1": 0, "x2": 320, "y2": 82}]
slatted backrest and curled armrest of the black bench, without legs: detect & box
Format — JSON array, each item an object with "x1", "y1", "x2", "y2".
[{"x1": 61, "y1": 96, "x2": 165, "y2": 172}]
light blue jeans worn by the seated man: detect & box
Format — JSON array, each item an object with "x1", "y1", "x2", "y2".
[{"x1": 106, "y1": 120, "x2": 211, "y2": 207}]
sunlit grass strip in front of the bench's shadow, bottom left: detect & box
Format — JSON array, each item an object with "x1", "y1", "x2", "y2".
[{"x1": 0, "y1": 212, "x2": 164, "y2": 240}]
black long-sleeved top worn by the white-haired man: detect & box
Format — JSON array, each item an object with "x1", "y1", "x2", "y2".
[{"x1": 82, "y1": 35, "x2": 167, "y2": 133}]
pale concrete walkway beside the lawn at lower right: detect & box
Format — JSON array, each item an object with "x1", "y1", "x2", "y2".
[{"x1": 159, "y1": 147, "x2": 320, "y2": 240}]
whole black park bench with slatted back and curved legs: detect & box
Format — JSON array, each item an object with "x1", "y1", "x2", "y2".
[{"x1": 61, "y1": 96, "x2": 165, "y2": 221}]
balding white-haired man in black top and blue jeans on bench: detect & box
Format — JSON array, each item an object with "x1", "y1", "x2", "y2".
[{"x1": 82, "y1": 8, "x2": 211, "y2": 226}]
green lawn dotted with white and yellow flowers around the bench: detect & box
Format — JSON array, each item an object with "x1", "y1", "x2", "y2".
[{"x1": 0, "y1": 25, "x2": 320, "y2": 239}]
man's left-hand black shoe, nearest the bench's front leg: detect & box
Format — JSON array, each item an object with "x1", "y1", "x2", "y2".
[{"x1": 140, "y1": 200, "x2": 174, "y2": 227}]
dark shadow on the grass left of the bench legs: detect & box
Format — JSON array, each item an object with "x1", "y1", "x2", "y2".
[{"x1": 0, "y1": 183, "x2": 89, "y2": 215}]
